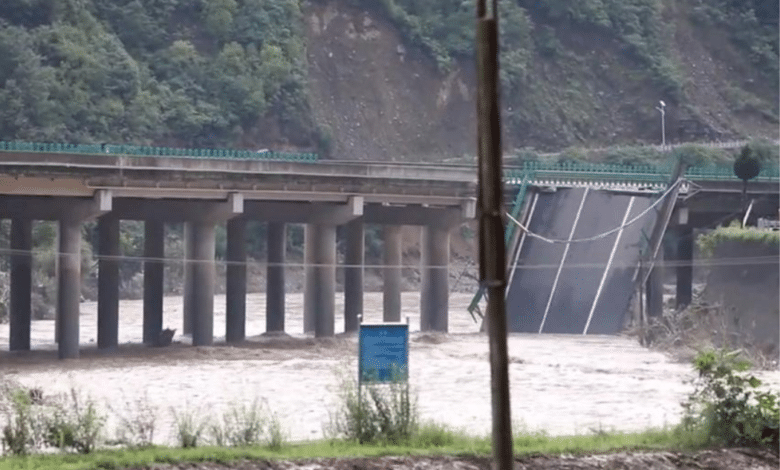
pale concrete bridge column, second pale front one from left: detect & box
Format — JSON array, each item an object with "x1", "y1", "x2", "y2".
[{"x1": 191, "y1": 221, "x2": 215, "y2": 346}]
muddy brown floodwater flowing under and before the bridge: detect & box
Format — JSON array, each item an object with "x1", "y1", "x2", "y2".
[{"x1": 0, "y1": 292, "x2": 780, "y2": 444}]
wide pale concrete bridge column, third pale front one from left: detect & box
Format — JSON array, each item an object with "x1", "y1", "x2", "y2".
[{"x1": 303, "y1": 224, "x2": 336, "y2": 337}]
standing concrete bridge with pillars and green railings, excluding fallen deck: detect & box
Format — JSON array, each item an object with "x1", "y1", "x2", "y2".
[{"x1": 0, "y1": 143, "x2": 778, "y2": 358}]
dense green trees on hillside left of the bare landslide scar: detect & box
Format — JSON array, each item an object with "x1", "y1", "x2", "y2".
[{"x1": 0, "y1": 0, "x2": 314, "y2": 147}]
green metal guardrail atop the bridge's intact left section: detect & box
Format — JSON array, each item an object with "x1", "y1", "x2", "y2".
[{"x1": 0, "y1": 142, "x2": 319, "y2": 163}]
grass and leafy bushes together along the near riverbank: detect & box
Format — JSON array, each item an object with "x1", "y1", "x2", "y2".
[{"x1": 0, "y1": 350, "x2": 780, "y2": 470}]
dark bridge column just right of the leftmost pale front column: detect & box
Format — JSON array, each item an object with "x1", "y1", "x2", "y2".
[{"x1": 98, "y1": 215, "x2": 119, "y2": 349}]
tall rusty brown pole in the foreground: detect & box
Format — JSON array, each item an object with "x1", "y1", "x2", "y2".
[{"x1": 476, "y1": 0, "x2": 513, "y2": 470}]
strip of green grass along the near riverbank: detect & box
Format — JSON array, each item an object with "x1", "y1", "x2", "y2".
[{"x1": 0, "y1": 429, "x2": 704, "y2": 470}]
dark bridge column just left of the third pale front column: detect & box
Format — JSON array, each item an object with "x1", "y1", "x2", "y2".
[{"x1": 265, "y1": 222, "x2": 287, "y2": 332}]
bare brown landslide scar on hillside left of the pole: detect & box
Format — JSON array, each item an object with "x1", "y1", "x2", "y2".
[{"x1": 305, "y1": 2, "x2": 475, "y2": 161}]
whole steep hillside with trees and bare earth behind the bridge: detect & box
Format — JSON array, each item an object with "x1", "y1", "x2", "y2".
[{"x1": 0, "y1": 0, "x2": 778, "y2": 159}]
